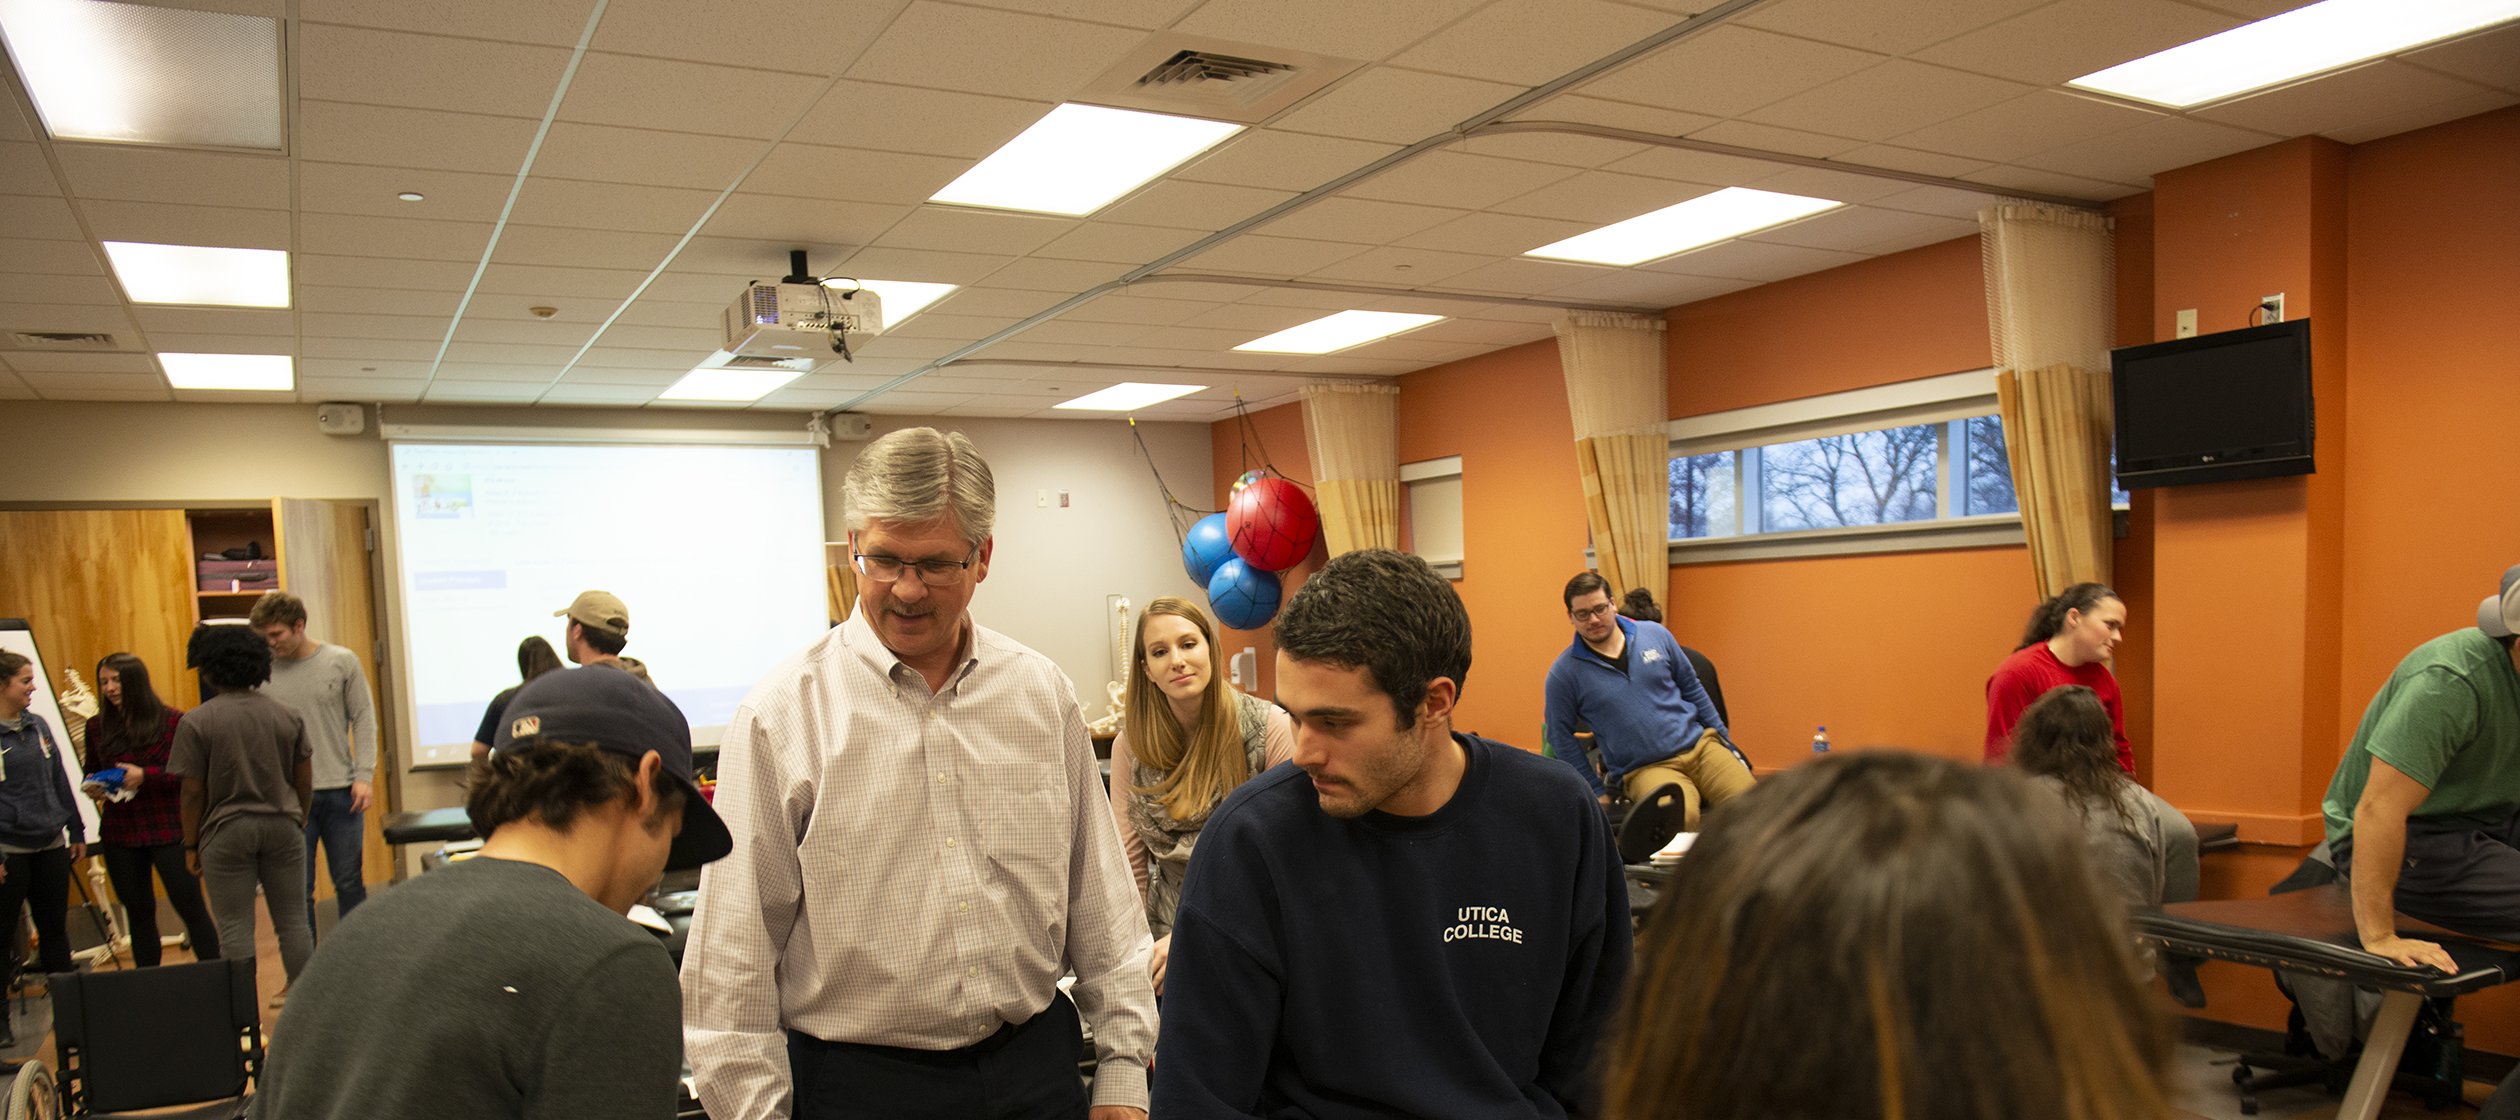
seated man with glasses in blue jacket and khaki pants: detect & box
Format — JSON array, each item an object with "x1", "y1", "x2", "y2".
[{"x1": 1542, "y1": 573, "x2": 1751, "y2": 832}]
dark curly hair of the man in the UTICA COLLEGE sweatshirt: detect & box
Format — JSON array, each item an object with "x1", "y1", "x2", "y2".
[{"x1": 1278, "y1": 547, "x2": 1469, "y2": 732}]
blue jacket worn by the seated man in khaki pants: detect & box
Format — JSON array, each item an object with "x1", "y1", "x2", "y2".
[{"x1": 1542, "y1": 615, "x2": 1749, "y2": 795}]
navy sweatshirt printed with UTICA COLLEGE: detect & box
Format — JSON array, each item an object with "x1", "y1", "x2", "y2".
[{"x1": 1154, "y1": 734, "x2": 1628, "y2": 1120}]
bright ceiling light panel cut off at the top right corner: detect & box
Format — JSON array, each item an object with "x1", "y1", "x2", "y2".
[{"x1": 2066, "y1": 0, "x2": 2520, "y2": 108}]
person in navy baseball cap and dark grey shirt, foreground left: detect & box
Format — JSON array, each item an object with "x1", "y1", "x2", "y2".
[{"x1": 252, "y1": 668, "x2": 731, "y2": 1120}]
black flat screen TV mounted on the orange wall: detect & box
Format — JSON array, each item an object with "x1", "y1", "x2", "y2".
[{"x1": 2109, "y1": 318, "x2": 2316, "y2": 489}]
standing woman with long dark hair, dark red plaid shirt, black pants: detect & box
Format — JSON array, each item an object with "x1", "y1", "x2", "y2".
[{"x1": 86, "y1": 653, "x2": 219, "y2": 969}]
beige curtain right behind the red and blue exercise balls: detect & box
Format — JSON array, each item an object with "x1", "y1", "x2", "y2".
[{"x1": 1303, "y1": 381, "x2": 1401, "y2": 555}]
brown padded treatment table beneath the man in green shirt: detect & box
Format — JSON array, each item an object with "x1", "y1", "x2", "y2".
[{"x1": 2134, "y1": 883, "x2": 2520, "y2": 1120}]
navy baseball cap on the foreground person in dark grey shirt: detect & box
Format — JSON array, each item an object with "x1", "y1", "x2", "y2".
[{"x1": 491, "y1": 666, "x2": 736, "y2": 870}]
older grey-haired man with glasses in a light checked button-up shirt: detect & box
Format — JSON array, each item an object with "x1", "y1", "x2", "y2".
[{"x1": 683, "y1": 429, "x2": 1154, "y2": 1120}]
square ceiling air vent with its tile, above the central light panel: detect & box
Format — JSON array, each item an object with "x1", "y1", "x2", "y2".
[{"x1": 1074, "y1": 33, "x2": 1363, "y2": 124}]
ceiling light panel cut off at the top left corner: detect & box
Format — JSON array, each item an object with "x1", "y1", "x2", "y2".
[{"x1": 0, "y1": 0, "x2": 280, "y2": 151}]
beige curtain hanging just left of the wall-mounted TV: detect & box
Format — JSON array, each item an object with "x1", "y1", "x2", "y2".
[{"x1": 1978, "y1": 202, "x2": 2114, "y2": 598}]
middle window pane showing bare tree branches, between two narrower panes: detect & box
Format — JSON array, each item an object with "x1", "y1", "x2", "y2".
[{"x1": 1759, "y1": 424, "x2": 1938, "y2": 532}]
